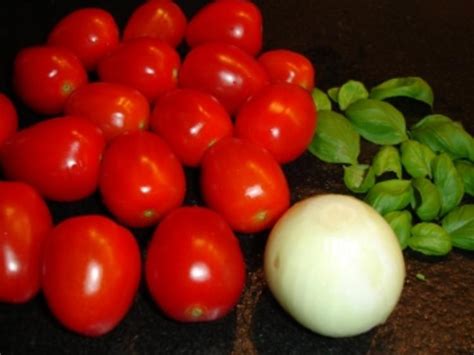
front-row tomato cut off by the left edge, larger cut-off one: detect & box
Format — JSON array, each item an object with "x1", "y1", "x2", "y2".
[{"x1": 0, "y1": 181, "x2": 52, "y2": 303}]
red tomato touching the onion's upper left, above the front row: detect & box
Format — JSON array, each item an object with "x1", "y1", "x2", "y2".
[{"x1": 201, "y1": 138, "x2": 290, "y2": 233}]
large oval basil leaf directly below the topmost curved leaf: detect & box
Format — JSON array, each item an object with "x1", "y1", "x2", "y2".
[{"x1": 345, "y1": 99, "x2": 407, "y2": 145}]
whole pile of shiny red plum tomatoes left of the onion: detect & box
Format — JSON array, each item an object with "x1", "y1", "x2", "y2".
[{"x1": 0, "y1": 0, "x2": 317, "y2": 336}]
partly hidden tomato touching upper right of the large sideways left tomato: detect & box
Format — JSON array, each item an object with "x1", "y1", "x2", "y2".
[{"x1": 64, "y1": 82, "x2": 150, "y2": 141}]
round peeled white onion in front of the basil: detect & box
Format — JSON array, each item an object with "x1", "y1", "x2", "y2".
[{"x1": 264, "y1": 194, "x2": 405, "y2": 337}]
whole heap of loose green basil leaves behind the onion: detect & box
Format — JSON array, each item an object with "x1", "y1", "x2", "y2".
[{"x1": 308, "y1": 77, "x2": 474, "y2": 256}]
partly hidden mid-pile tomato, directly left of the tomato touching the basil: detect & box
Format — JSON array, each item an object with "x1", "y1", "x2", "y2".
[{"x1": 150, "y1": 89, "x2": 233, "y2": 167}]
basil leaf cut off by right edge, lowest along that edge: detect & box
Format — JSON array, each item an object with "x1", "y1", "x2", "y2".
[{"x1": 441, "y1": 205, "x2": 474, "y2": 250}]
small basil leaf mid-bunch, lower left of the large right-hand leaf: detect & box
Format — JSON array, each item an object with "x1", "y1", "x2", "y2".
[{"x1": 400, "y1": 140, "x2": 436, "y2": 178}]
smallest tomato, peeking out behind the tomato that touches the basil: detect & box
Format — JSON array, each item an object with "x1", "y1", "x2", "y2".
[{"x1": 258, "y1": 49, "x2": 316, "y2": 91}]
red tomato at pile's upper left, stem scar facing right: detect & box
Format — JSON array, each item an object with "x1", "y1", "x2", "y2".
[{"x1": 13, "y1": 46, "x2": 88, "y2": 115}]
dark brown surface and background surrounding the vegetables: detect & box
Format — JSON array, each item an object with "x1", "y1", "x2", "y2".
[{"x1": 0, "y1": 0, "x2": 474, "y2": 355}]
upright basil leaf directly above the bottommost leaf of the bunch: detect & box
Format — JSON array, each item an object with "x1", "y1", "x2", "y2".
[{"x1": 412, "y1": 178, "x2": 441, "y2": 221}]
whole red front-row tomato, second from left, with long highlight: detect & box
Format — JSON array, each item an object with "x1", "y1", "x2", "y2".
[{"x1": 42, "y1": 215, "x2": 141, "y2": 336}]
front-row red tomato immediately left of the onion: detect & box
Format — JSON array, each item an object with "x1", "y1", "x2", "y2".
[{"x1": 145, "y1": 207, "x2": 245, "y2": 322}]
